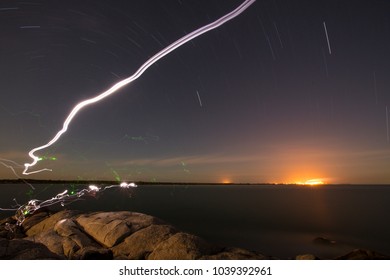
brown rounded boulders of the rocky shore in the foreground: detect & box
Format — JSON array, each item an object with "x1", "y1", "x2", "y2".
[{"x1": 0, "y1": 210, "x2": 390, "y2": 260}]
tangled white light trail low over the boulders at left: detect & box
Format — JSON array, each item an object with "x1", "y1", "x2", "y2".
[{"x1": 0, "y1": 182, "x2": 137, "y2": 226}]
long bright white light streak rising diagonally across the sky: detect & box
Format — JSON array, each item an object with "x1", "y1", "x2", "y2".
[{"x1": 23, "y1": 0, "x2": 256, "y2": 175}]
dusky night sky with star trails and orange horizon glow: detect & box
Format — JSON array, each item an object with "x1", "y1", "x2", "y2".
[{"x1": 0, "y1": 0, "x2": 390, "y2": 184}]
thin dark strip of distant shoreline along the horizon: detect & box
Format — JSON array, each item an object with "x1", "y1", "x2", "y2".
[{"x1": 0, "y1": 179, "x2": 390, "y2": 187}]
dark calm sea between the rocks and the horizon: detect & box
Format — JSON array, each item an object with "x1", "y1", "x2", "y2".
[{"x1": 0, "y1": 184, "x2": 390, "y2": 259}]
